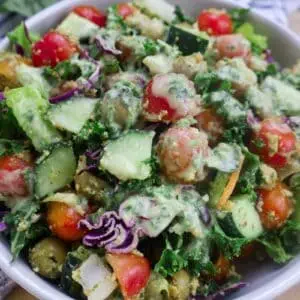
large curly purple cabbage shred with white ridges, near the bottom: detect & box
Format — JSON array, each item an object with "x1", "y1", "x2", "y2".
[{"x1": 79, "y1": 211, "x2": 139, "y2": 253}]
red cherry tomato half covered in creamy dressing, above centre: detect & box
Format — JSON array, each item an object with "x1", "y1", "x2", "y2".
[{"x1": 143, "y1": 73, "x2": 201, "y2": 122}]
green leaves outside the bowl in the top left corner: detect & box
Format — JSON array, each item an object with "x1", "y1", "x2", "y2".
[{"x1": 0, "y1": 0, "x2": 56, "y2": 17}]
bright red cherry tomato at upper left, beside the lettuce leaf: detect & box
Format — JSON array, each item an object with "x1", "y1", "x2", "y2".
[{"x1": 32, "y1": 31, "x2": 77, "y2": 67}]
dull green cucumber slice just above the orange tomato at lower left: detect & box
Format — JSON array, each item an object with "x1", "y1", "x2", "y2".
[{"x1": 35, "y1": 145, "x2": 77, "y2": 198}]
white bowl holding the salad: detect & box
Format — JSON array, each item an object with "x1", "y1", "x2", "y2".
[{"x1": 0, "y1": 0, "x2": 300, "y2": 300}]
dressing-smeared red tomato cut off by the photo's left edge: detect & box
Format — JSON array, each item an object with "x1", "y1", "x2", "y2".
[{"x1": 0, "y1": 156, "x2": 31, "y2": 197}]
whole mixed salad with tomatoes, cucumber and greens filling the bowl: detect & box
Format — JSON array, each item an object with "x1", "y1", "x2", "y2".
[{"x1": 0, "y1": 0, "x2": 300, "y2": 300}]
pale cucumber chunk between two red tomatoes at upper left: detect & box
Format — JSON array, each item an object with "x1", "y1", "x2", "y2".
[{"x1": 56, "y1": 13, "x2": 99, "y2": 39}]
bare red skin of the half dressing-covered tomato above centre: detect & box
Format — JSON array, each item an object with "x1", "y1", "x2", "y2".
[{"x1": 144, "y1": 80, "x2": 176, "y2": 121}]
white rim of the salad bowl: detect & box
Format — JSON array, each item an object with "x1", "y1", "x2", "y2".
[{"x1": 0, "y1": 0, "x2": 300, "y2": 300}]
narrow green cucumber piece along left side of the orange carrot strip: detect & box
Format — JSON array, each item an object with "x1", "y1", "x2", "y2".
[{"x1": 209, "y1": 171, "x2": 230, "y2": 208}]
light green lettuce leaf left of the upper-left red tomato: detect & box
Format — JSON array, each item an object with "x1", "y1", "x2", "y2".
[{"x1": 7, "y1": 22, "x2": 39, "y2": 57}]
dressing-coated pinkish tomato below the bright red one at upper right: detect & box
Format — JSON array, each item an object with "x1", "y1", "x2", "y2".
[{"x1": 215, "y1": 34, "x2": 251, "y2": 58}]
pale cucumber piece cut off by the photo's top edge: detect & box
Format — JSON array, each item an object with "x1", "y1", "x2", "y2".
[{"x1": 133, "y1": 0, "x2": 176, "y2": 23}]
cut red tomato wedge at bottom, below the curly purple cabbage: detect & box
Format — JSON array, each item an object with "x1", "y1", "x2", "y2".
[{"x1": 106, "y1": 254, "x2": 151, "y2": 299}]
